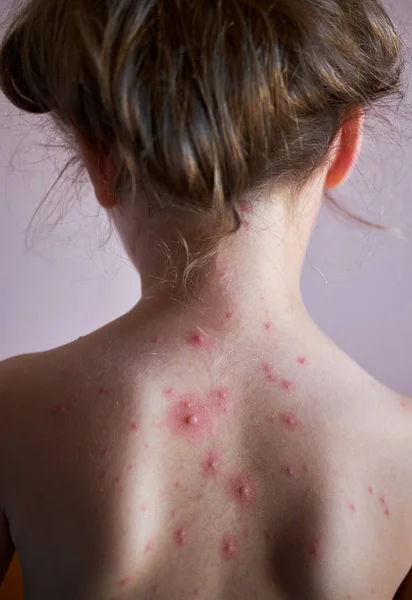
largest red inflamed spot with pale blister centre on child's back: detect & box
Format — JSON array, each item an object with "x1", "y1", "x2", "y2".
[{"x1": 167, "y1": 397, "x2": 213, "y2": 442}]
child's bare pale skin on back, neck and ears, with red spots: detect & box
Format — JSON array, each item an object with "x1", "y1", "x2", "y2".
[{"x1": 0, "y1": 111, "x2": 412, "y2": 600}]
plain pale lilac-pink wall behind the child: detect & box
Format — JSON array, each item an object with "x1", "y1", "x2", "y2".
[{"x1": 0, "y1": 0, "x2": 412, "y2": 395}]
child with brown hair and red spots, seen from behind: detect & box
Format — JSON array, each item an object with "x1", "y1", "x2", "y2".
[{"x1": 0, "y1": 0, "x2": 412, "y2": 600}]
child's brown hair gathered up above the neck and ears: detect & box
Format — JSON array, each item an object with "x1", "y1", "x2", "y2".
[{"x1": 0, "y1": 0, "x2": 403, "y2": 284}]
